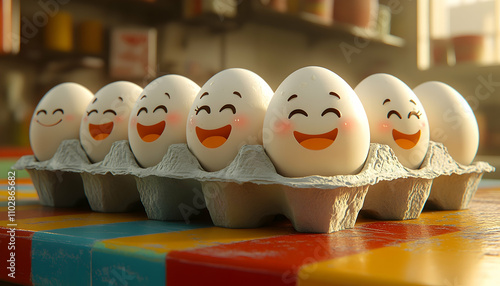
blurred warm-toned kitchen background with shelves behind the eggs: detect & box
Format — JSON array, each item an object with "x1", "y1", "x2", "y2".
[{"x1": 0, "y1": 0, "x2": 500, "y2": 176}]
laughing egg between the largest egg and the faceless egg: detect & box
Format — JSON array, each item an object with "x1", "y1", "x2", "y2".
[{"x1": 354, "y1": 73, "x2": 429, "y2": 169}]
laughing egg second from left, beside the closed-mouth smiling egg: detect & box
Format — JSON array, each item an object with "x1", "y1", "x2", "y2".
[{"x1": 80, "y1": 81, "x2": 142, "y2": 163}]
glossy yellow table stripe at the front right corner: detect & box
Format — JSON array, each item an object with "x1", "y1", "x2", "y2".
[{"x1": 298, "y1": 232, "x2": 500, "y2": 286}]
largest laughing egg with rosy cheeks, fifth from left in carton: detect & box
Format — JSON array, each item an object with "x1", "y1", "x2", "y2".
[{"x1": 263, "y1": 66, "x2": 370, "y2": 177}]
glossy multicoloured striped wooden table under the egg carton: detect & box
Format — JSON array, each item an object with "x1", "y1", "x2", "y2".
[{"x1": 0, "y1": 171, "x2": 500, "y2": 286}]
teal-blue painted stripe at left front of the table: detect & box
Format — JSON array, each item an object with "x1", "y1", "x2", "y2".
[{"x1": 31, "y1": 220, "x2": 213, "y2": 285}]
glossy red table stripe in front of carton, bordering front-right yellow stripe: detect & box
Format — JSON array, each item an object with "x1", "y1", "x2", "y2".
[{"x1": 166, "y1": 222, "x2": 460, "y2": 285}]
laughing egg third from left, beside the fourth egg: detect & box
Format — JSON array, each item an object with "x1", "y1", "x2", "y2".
[{"x1": 128, "y1": 75, "x2": 200, "y2": 167}]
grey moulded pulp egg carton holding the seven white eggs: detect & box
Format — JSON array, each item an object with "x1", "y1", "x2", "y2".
[{"x1": 14, "y1": 140, "x2": 494, "y2": 233}]
